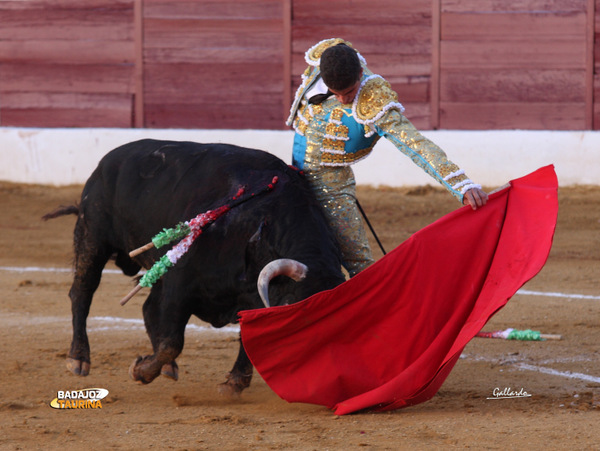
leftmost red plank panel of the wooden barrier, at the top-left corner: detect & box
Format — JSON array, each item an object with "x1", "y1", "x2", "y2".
[{"x1": 0, "y1": 0, "x2": 135, "y2": 127}]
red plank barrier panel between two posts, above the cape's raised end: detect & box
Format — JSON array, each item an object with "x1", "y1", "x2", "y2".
[{"x1": 440, "y1": 0, "x2": 590, "y2": 129}]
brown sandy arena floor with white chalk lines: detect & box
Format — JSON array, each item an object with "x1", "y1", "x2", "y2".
[{"x1": 0, "y1": 182, "x2": 600, "y2": 450}]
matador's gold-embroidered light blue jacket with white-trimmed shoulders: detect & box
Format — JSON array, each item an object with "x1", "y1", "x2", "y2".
[{"x1": 287, "y1": 38, "x2": 480, "y2": 201}]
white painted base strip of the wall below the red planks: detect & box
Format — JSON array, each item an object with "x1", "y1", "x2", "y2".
[{"x1": 0, "y1": 127, "x2": 600, "y2": 187}]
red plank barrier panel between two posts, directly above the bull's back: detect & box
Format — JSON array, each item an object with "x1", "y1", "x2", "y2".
[{"x1": 144, "y1": 0, "x2": 284, "y2": 128}]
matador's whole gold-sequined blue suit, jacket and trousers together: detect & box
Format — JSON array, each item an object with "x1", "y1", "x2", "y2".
[{"x1": 287, "y1": 39, "x2": 474, "y2": 276}]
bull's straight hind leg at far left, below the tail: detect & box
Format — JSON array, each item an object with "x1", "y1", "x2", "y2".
[{"x1": 67, "y1": 248, "x2": 110, "y2": 376}]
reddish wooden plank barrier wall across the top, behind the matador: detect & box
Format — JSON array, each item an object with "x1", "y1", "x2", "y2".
[{"x1": 0, "y1": 0, "x2": 600, "y2": 130}]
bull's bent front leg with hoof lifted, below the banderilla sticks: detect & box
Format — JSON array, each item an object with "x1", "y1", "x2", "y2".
[{"x1": 129, "y1": 296, "x2": 191, "y2": 384}]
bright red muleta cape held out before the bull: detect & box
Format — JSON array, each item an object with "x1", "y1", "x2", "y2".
[{"x1": 240, "y1": 166, "x2": 558, "y2": 415}]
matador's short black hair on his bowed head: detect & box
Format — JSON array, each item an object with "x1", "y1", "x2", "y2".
[{"x1": 320, "y1": 44, "x2": 362, "y2": 91}]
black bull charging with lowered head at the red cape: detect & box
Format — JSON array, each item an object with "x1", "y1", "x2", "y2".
[{"x1": 46, "y1": 140, "x2": 344, "y2": 393}]
